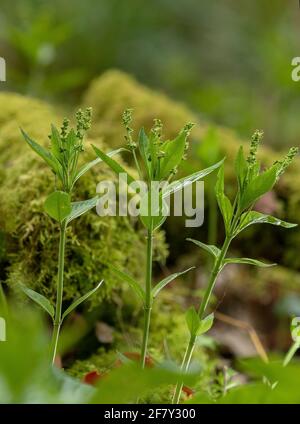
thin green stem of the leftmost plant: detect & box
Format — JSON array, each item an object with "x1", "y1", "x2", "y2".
[{"x1": 50, "y1": 222, "x2": 67, "y2": 364}]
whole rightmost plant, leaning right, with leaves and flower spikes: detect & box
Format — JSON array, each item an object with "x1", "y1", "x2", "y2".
[{"x1": 173, "y1": 131, "x2": 298, "y2": 403}]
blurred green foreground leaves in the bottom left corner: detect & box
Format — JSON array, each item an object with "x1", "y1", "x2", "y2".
[{"x1": 0, "y1": 305, "x2": 93, "y2": 403}]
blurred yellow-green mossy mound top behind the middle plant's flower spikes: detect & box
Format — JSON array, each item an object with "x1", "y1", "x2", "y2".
[{"x1": 83, "y1": 70, "x2": 207, "y2": 146}]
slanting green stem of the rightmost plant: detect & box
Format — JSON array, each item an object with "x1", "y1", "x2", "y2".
[{"x1": 172, "y1": 236, "x2": 232, "y2": 404}]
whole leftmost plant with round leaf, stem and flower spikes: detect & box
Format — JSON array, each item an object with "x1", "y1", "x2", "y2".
[{"x1": 21, "y1": 108, "x2": 120, "y2": 362}]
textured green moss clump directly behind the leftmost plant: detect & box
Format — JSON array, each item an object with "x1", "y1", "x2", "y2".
[{"x1": 0, "y1": 154, "x2": 149, "y2": 304}]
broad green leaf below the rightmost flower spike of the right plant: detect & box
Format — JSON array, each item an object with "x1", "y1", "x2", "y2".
[{"x1": 240, "y1": 166, "x2": 277, "y2": 210}]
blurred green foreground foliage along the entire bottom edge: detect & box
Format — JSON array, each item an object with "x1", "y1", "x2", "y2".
[{"x1": 0, "y1": 304, "x2": 300, "y2": 404}]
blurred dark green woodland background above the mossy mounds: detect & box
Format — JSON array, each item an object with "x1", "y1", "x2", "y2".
[{"x1": 0, "y1": 0, "x2": 300, "y2": 148}]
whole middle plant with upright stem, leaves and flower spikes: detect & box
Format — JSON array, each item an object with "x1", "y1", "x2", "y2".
[{"x1": 93, "y1": 109, "x2": 222, "y2": 367}]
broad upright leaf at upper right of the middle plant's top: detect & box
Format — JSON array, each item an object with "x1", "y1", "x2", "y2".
[{"x1": 159, "y1": 130, "x2": 186, "y2": 180}]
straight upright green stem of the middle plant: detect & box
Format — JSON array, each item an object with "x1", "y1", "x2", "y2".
[{"x1": 141, "y1": 225, "x2": 153, "y2": 368}]
